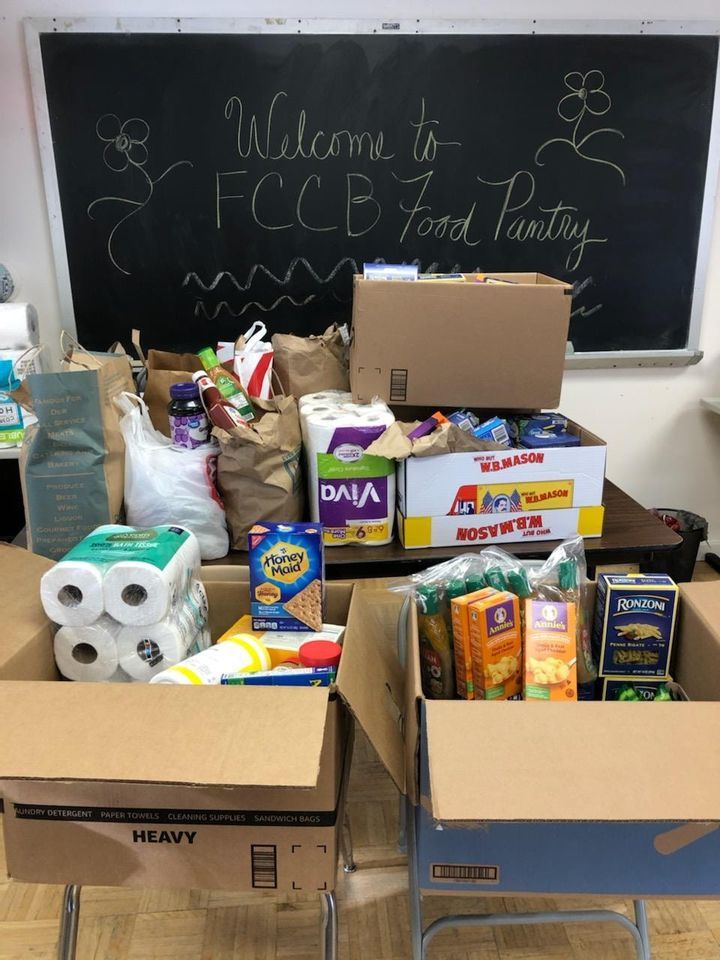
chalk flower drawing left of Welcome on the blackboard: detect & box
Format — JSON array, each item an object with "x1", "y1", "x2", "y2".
[{"x1": 87, "y1": 113, "x2": 192, "y2": 276}]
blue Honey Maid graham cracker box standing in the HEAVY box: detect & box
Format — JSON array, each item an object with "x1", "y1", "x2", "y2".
[{"x1": 248, "y1": 523, "x2": 325, "y2": 631}]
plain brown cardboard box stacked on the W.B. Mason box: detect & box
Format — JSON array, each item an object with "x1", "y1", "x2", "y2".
[{"x1": 350, "y1": 273, "x2": 572, "y2": 410}]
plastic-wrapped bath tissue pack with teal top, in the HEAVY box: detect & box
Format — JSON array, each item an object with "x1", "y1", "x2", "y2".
[{"x1": 40, "y1": 524, "x2": 210, "y2": 682}]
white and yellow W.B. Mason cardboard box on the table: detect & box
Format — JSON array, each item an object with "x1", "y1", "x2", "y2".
[{"x1": 397, "y1": 421, "x2": 607, "y2": 548}]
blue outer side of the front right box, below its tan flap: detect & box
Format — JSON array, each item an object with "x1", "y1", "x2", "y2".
[{"x1": 415, "y1": 702, "x2": 720, "y2": 897}]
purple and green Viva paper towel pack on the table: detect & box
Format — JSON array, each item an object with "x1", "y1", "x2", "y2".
[{"x1": 299, "y1": 390, "x2": 395, "y2": 546}]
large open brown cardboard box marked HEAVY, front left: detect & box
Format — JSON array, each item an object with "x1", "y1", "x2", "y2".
[{"x1": 0, "y1": 546, "x2": 352, "y2": 892}]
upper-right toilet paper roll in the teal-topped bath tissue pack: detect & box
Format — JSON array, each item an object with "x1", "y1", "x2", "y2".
[{"x1": 103, "y1": 534, "x2": 200, "y2": 626}]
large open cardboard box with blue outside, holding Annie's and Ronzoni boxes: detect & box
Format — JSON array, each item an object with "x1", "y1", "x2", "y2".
[{"x1": 338, "y1": 582, "x2": 720, "y2": 897}]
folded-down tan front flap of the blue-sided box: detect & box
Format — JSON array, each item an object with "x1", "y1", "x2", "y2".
[{"x1": 426, "y1": 701, "x2": 720, "y2": 822}]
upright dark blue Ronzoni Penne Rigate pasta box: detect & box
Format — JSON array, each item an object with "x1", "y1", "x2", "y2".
[{"x1": 593, "y1": 573, "x2": 679, "y2": 677}]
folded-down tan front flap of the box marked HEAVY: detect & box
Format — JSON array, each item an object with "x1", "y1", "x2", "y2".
[{"x1": 0, "y1": 681, "x2": 327, "y2": 788}]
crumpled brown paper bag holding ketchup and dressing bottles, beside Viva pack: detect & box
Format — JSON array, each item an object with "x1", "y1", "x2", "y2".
[{"x1": 213, "y1": 397, "x2": 305, "y2": 550}]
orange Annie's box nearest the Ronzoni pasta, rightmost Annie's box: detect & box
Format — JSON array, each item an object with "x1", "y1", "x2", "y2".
[{"x1": 524, "y1": 600, "x2": 577, "y2": 703}]
